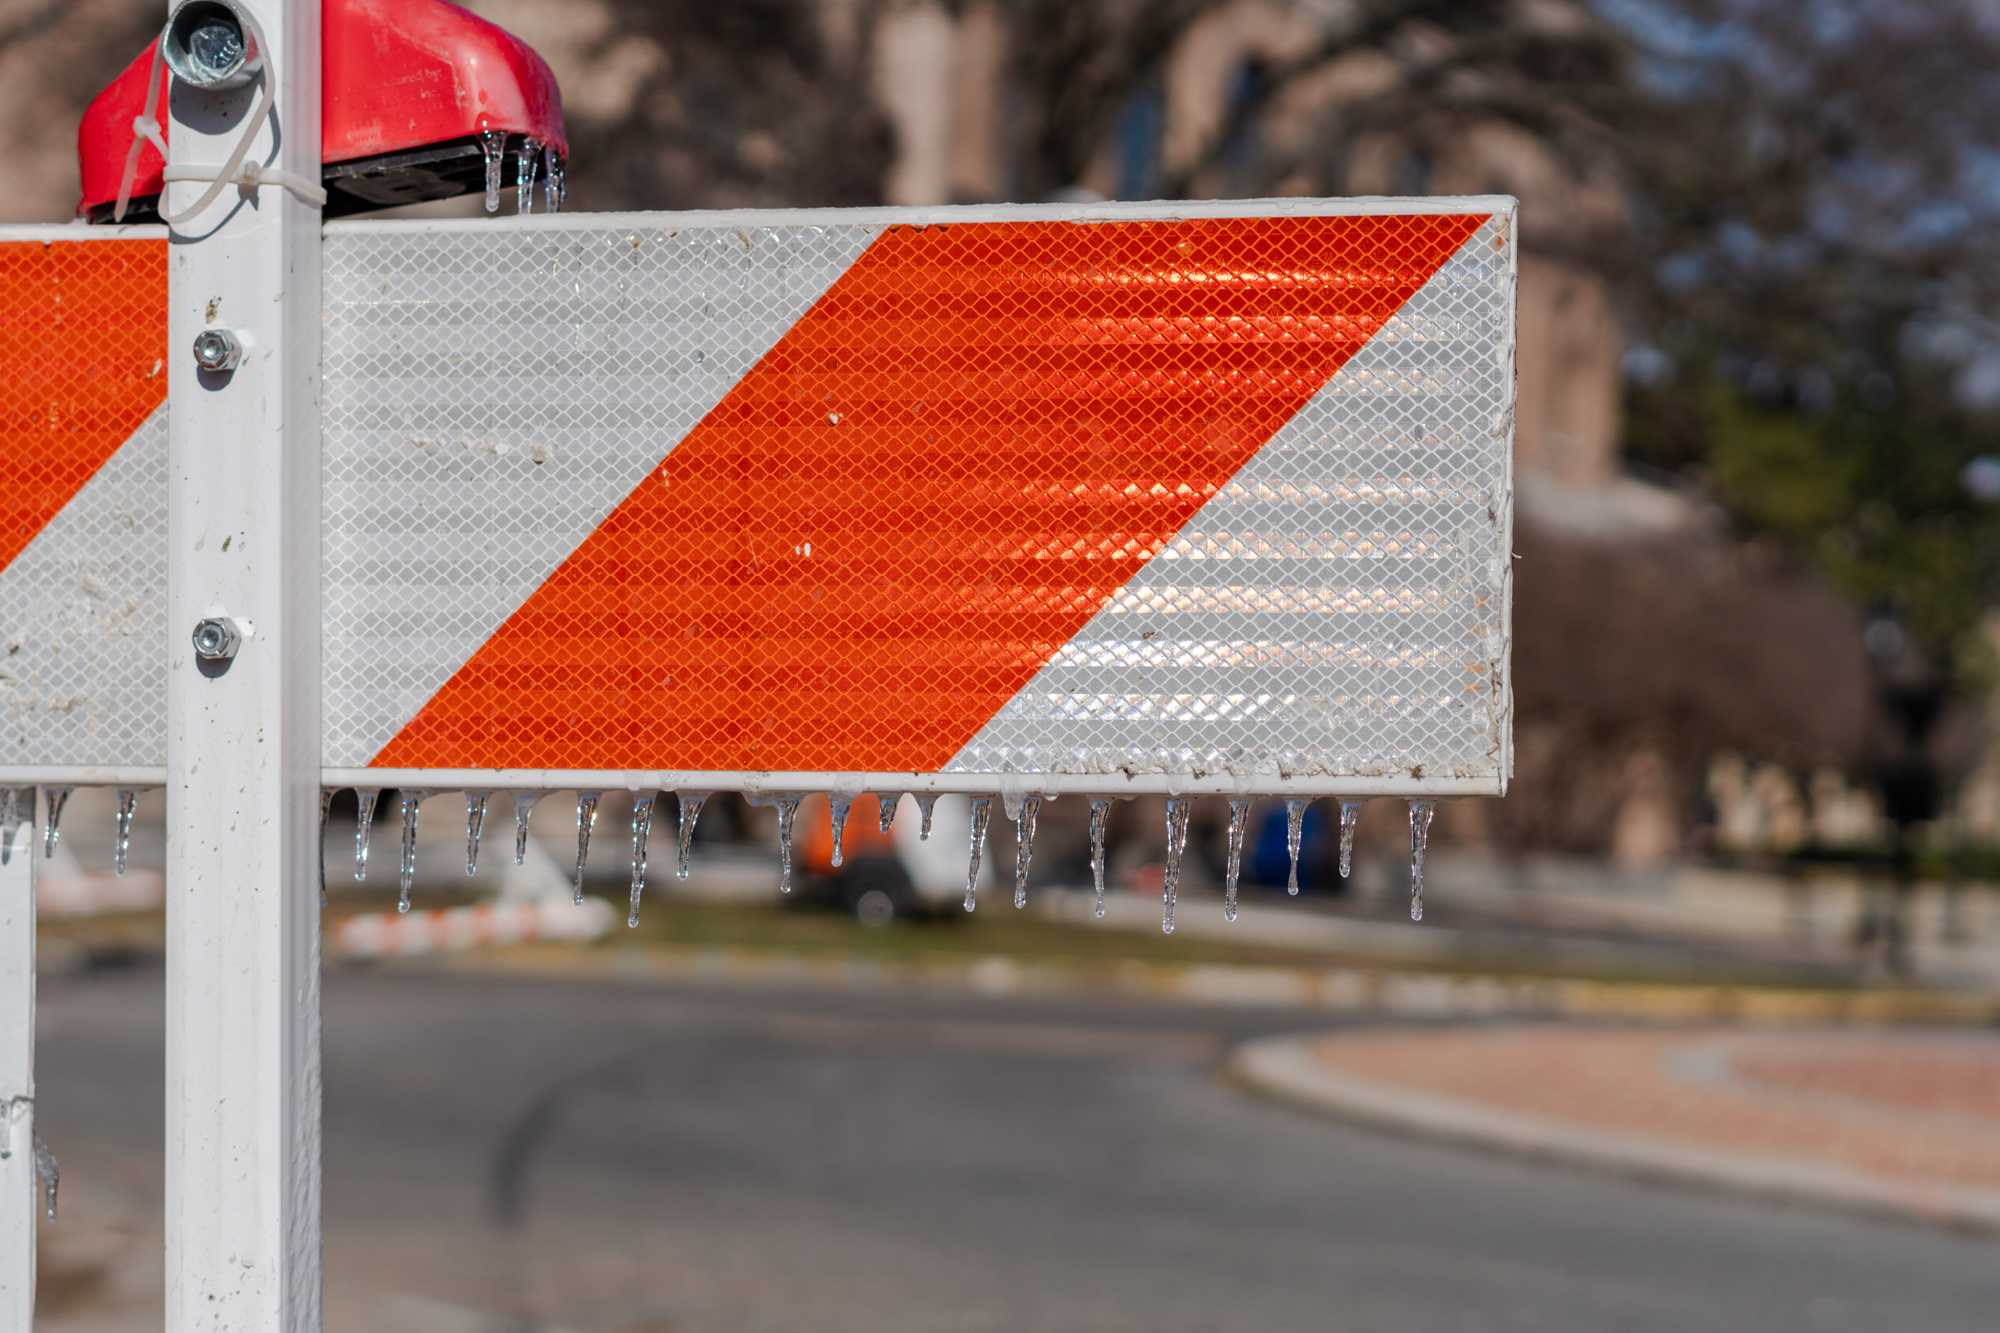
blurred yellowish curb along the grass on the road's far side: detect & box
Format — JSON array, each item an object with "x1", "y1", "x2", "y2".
[{"x1": 410, "y1": 932, "x2": 2000, "y2": 1027}]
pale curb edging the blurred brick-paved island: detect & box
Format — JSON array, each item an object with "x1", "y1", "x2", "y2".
[{"x1": 1224, "y1": 1037, "x2": 2000, "y2": 1235}]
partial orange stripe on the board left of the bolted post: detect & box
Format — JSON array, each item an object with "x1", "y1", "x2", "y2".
[{"x1": 0, "y1": 236, "x2": 166, "y2": 570}]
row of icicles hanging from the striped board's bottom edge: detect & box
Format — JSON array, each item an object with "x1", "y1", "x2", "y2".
[{"x1": 0, "y1": 787, "x2": 1436, "y2": 935}]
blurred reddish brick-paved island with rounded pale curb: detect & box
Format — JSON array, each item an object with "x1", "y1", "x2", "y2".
[{"x1": 1230, "y1": 1027, "x2": 2000, "y2": 1235}]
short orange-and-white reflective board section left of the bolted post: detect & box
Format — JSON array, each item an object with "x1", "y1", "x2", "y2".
[{"x1": 0, "y1": 228, "x2": 166, "y2": 773}]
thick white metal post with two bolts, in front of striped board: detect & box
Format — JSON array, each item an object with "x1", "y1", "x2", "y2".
[{"x1": 164, "y1": 0, "x2": 320, "y2": 1333}]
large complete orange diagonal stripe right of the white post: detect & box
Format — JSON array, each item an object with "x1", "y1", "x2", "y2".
[{"x1": 374, "y1": 214, "x2": 1484, "y2": 773}]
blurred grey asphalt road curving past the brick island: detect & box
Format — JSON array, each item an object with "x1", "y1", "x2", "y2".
[{"x1": 31, "y1": 969, "x2": 2000, "y2": 1333}]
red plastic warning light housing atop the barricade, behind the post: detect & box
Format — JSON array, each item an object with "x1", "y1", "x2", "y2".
[{"x1": 76, "y1": 0, "x2": 570, "y2": 222}]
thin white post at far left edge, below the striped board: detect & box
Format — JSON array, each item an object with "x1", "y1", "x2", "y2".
[{"x1": 0, "y1": 793, "x2": 38, "y2": 1333}]
